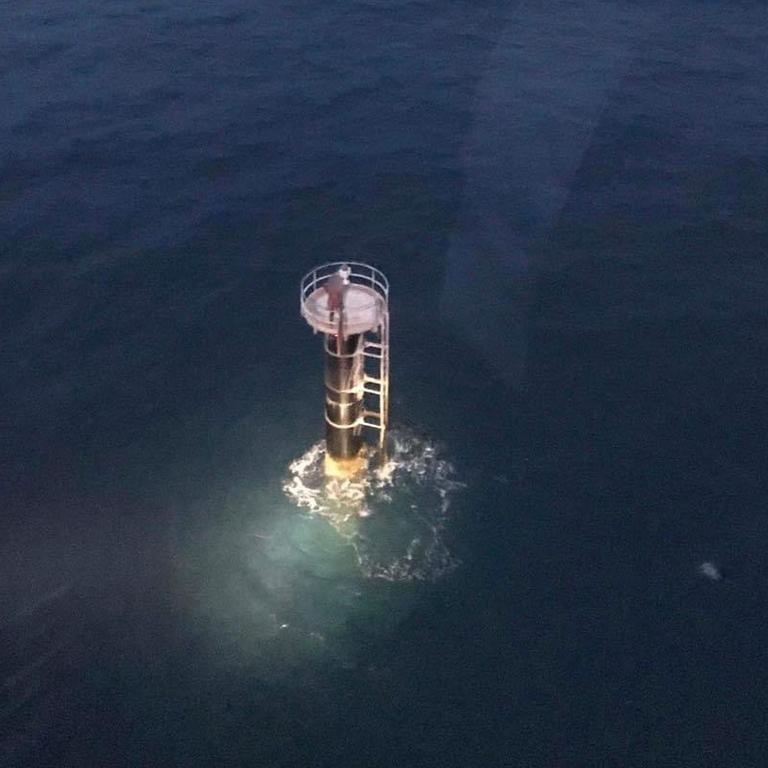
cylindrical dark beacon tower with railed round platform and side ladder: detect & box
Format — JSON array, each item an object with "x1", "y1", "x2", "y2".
[{"x1": 300, "y1": 261, "x2": 389, "y2": 477}]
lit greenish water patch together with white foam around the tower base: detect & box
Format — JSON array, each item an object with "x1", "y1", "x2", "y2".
[{"x1": 177, "y1": 430, "x2": 463, "y2": 680}]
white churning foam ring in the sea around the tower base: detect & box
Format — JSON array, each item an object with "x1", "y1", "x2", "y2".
[{"x1": 283, "y1": 429, "x2": 464, "y2": 581}]
